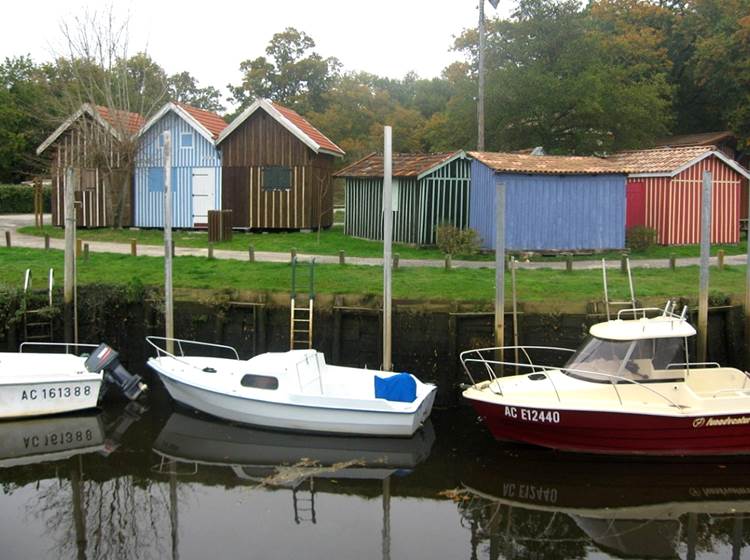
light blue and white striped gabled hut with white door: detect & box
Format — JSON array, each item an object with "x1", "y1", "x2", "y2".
[{"x1": 133, "y1": 102, "x2": 227, "y2": 228}]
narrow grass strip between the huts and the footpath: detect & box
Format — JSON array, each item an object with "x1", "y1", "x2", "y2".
[{"x1": 19, "y1": 226, "x2": 747, "y2": 262}]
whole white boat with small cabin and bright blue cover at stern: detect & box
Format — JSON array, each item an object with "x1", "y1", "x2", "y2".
[{"x1": 146, "y1": 336, "x2": 436, "y2": 437}]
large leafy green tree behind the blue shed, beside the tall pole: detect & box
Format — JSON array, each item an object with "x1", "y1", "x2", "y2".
[{"x1": 444, "y1": 0, "x2": 671, "y2": 154}]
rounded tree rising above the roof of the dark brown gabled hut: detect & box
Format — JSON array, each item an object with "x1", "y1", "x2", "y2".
[{"x1": 227, "y1": 27, "x2": 341, "y2": 112}]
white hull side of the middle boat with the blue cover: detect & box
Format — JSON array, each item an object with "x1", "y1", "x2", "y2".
[{"x1": 157, "y1": 370, "x2": 435, "y2": 437}]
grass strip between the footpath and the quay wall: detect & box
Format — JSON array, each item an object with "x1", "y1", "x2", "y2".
[{"x1": 0, "y1": 248, "x2": 745, "y2": 303}]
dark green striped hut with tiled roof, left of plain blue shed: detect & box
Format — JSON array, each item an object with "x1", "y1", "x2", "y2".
[{"x1": 335, "y1": 151, "x2": 471, "y2": 245}]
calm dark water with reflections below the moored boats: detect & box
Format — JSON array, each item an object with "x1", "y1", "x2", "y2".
[{"x1": 0, "y1": 390, "x2": 750, "y2": 560}]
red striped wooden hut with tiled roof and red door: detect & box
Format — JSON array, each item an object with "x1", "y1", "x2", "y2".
[{"x1": 610, "y1": 146, "x2": 750, "y2": 245}]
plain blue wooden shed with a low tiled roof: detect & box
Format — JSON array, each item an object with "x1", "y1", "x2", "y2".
[{"x1": 469, "y1": 152, "x2": 627, "y2": 251}]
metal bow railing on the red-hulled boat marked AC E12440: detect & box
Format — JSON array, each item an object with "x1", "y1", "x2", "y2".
[{"x1": 460, "y1": 346, "x2": 683, "y2": 409}]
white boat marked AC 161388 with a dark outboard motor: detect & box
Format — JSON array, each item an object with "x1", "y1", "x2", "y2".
[{"x1": 0, "y1": 342, "x2": 146, "y2": 419}]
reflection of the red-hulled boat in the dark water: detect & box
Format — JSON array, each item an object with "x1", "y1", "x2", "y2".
[{"x1": 459, "y1": 448, "x2": 750, "y2": 558}]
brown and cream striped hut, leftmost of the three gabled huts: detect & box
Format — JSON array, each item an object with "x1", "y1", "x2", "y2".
[{"x1": 36, "y1": 103, "x2": 144, "y2": 227}]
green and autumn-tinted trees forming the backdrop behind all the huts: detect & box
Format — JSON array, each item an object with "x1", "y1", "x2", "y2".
[{"x1": 0, "y1": 0, "x2": 750, "y2": 183}]
